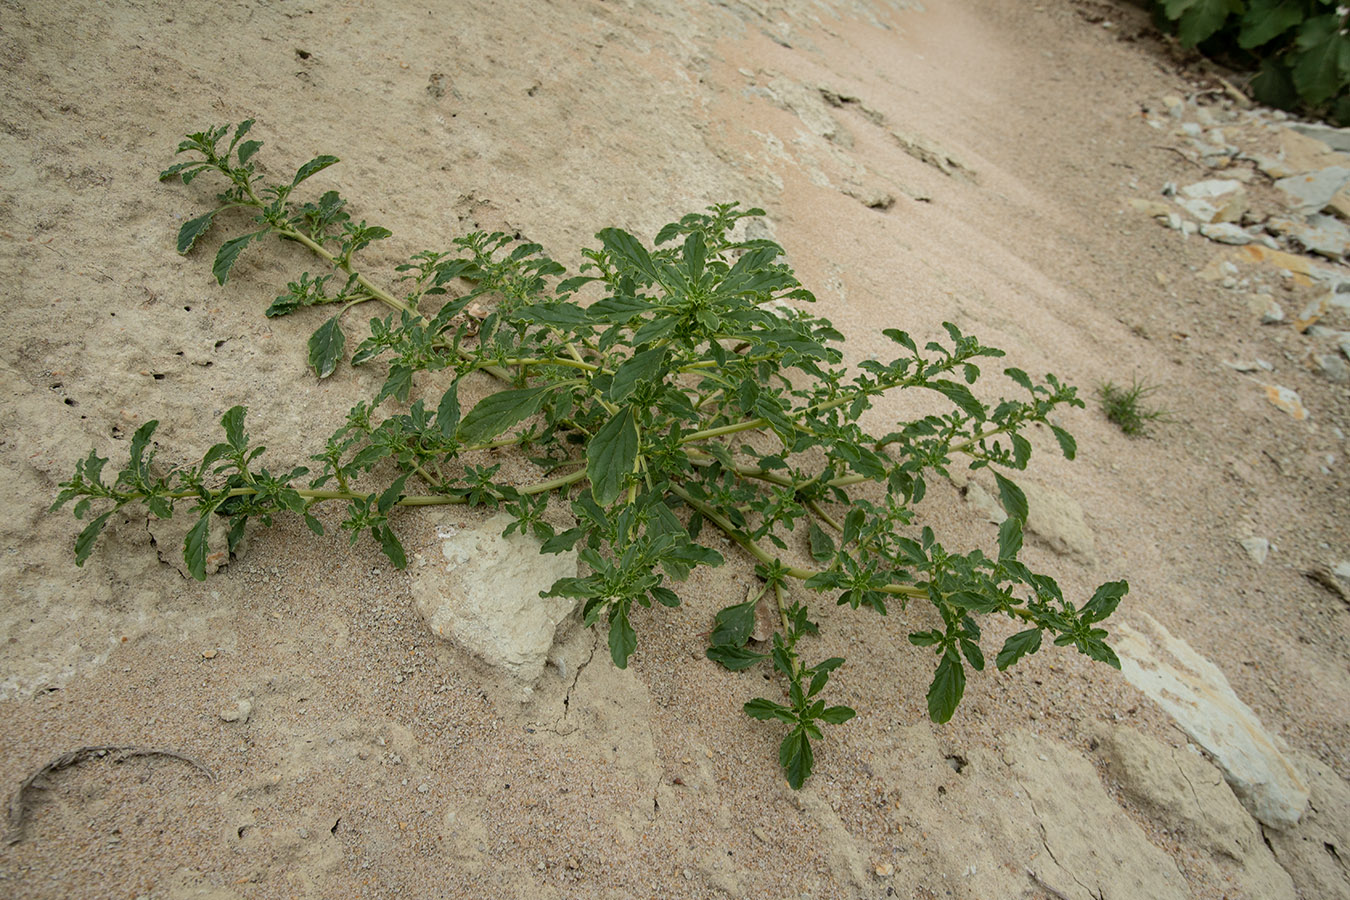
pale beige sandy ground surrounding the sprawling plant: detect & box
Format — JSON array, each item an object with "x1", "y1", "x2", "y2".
[{"x1": 0, "y1": 0, "x2": 1350, "y2": 900}]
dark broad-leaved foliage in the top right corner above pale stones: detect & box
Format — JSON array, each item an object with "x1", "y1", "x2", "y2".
[{"x1": 1153, "y1": 0, "x2": 1350, "y2": 124}]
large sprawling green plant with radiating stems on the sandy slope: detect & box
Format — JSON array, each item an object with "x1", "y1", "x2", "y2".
[{"x1": 53, "y1": 121, "x2": 1129, "y2": 787}]
